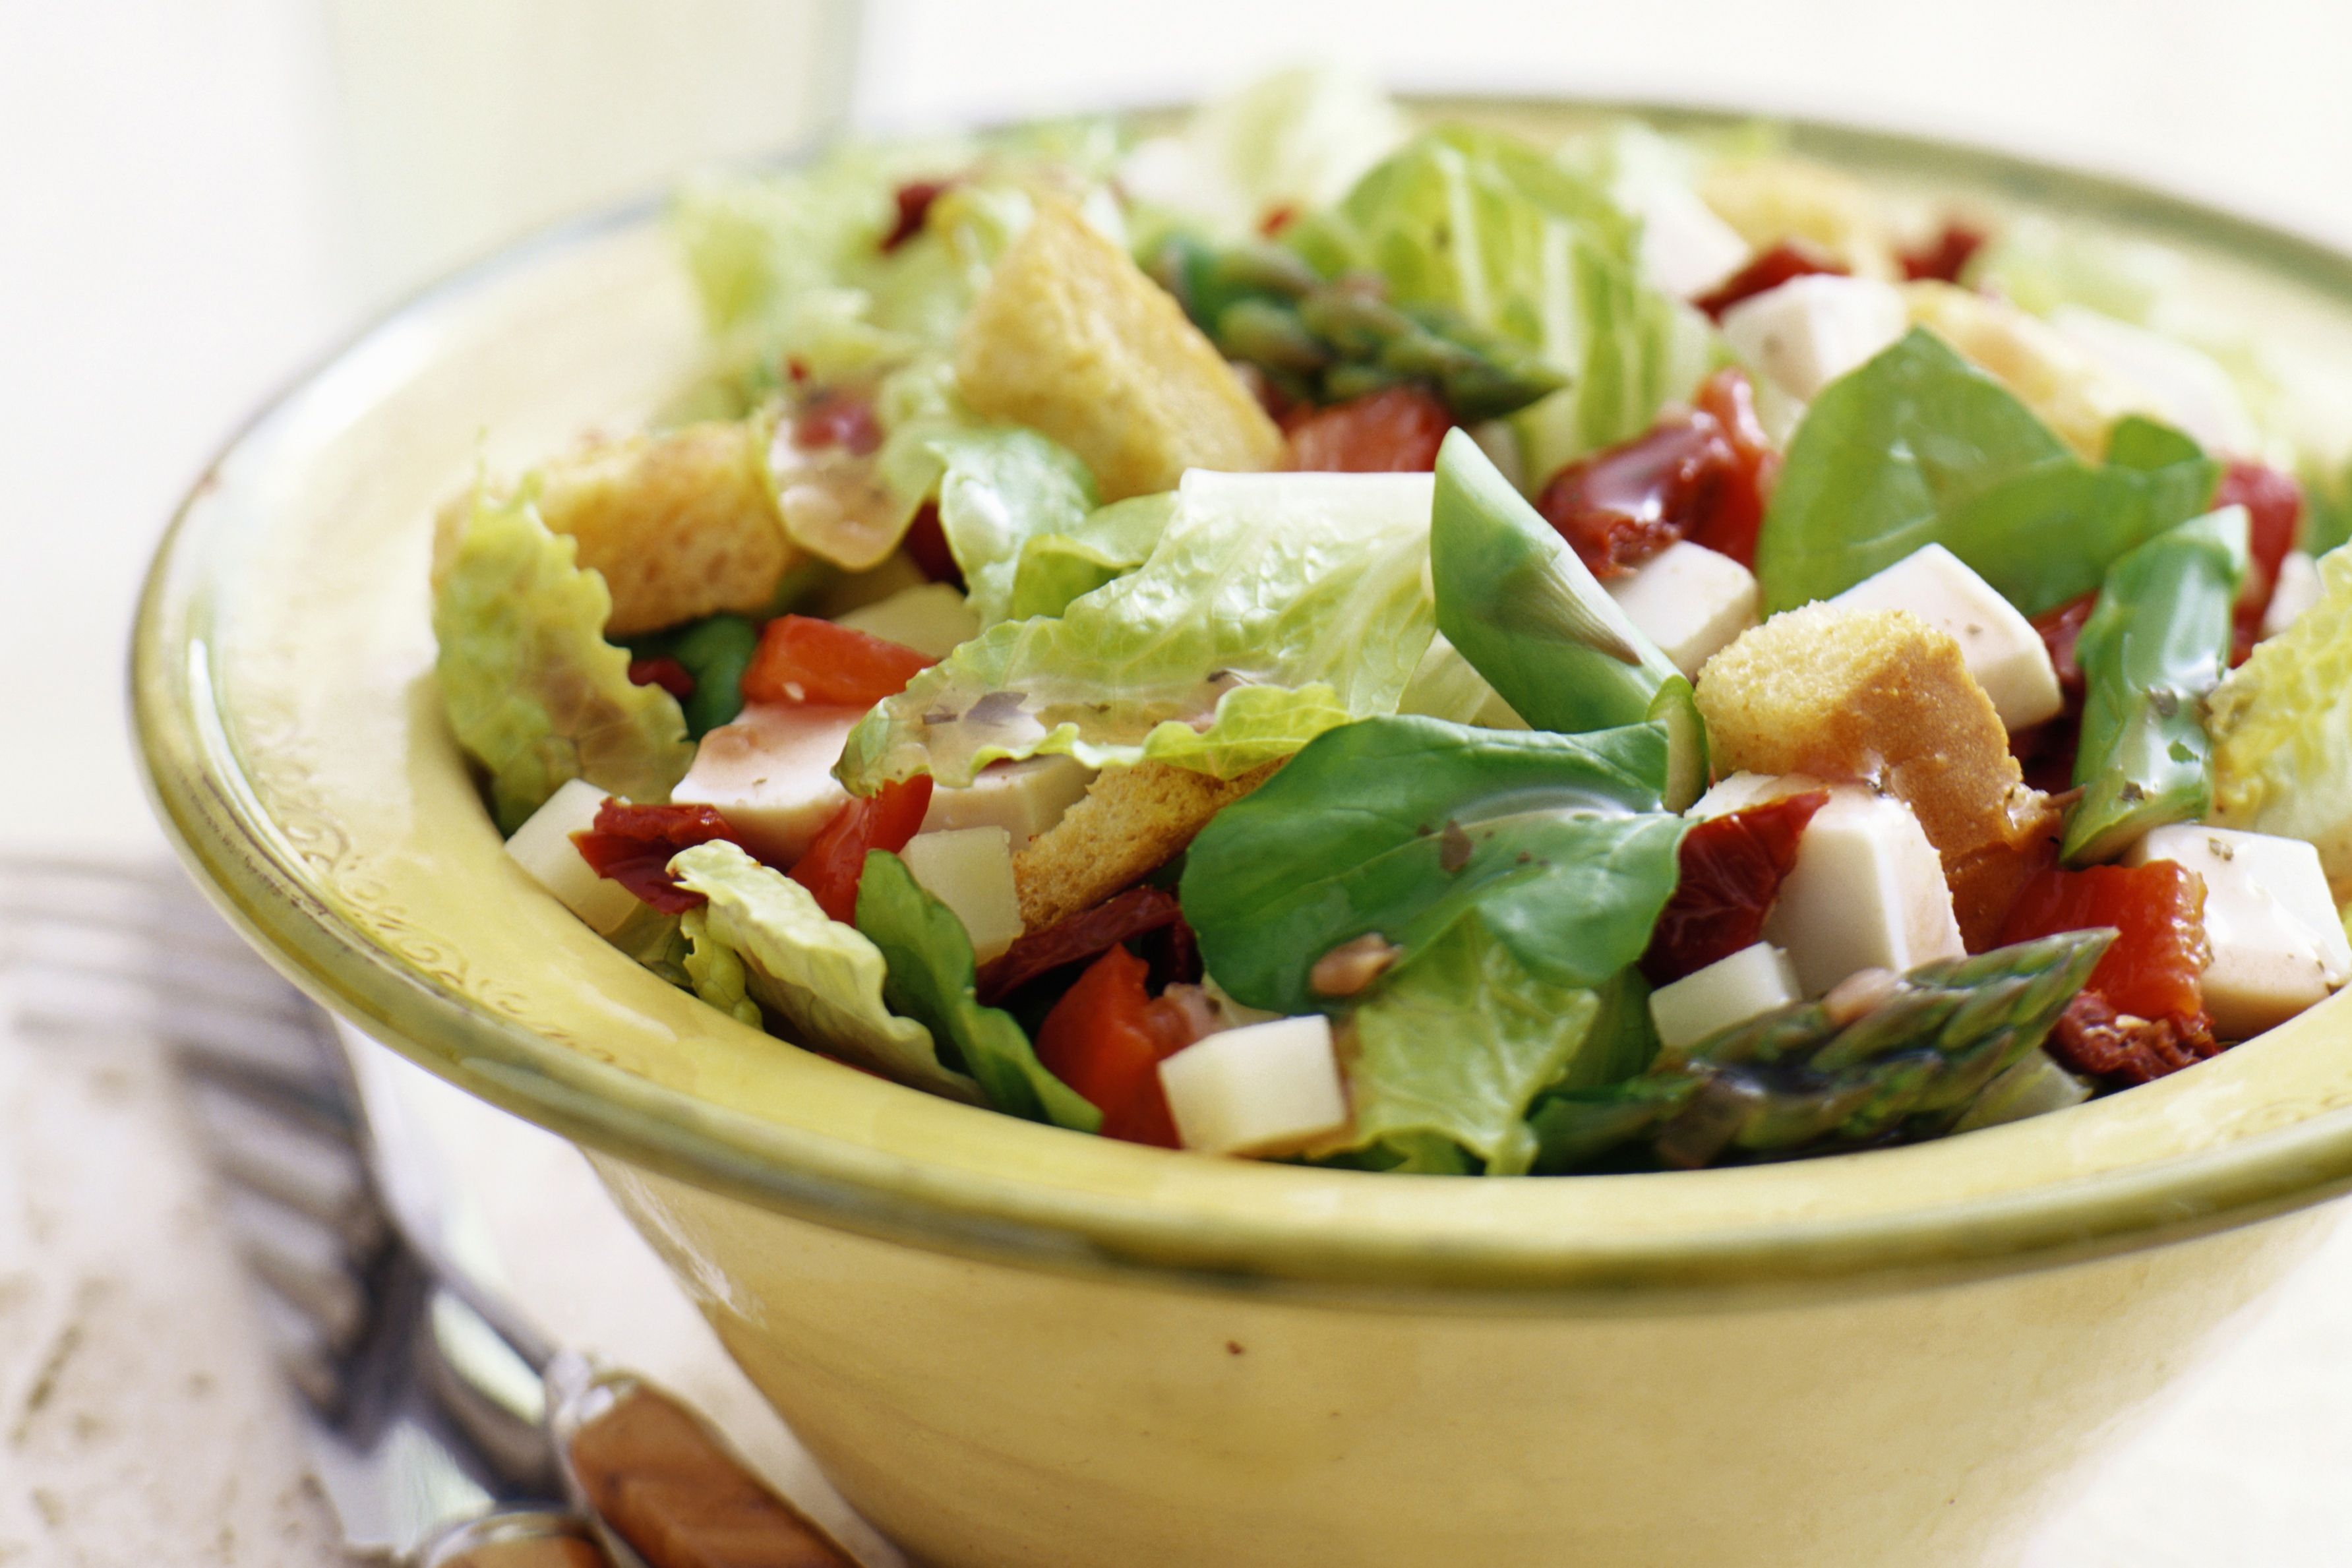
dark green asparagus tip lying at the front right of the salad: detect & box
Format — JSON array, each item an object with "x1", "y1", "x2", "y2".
[{"x1": 1529, "y1": 928, "x2": 2115, "y2": 1173}]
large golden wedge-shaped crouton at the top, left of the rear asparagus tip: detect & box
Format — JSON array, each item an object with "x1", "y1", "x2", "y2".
[{"x1": 955, "y1": 202, "x2": 1282, "y2": 500}]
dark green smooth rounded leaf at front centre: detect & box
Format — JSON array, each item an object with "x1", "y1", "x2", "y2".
[{"x1": 1178, "y1": 717, "x2": 1689, "y2": 1013}]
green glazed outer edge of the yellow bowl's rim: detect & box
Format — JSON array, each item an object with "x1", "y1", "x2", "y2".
[{"x1": 129, "y1": 94, "x2": 2352, "y2": 1312}]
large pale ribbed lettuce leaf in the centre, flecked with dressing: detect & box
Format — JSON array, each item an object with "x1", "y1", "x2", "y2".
[{"x1": 837, "y1": 470, "x2": 1432, "y2": 795}]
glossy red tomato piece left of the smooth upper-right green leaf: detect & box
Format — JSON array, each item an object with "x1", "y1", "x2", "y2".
[{"x1": 1536, "y1": 369, "x2": 1776, "y2": 581}]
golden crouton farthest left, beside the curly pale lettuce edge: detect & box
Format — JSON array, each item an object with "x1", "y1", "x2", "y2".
[{"x1": 433, "y1": 421, "x2": 800, "y2": 637}]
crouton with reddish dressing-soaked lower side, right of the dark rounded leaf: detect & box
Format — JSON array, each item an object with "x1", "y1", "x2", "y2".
[{"x1": 1698, "y1": 604, "x2": 2056, "y2": 950}]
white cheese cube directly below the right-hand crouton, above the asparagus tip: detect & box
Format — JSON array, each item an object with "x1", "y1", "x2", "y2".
[{"x1": 1764, "y1": 785, "x2": 1966, "y2": 997}]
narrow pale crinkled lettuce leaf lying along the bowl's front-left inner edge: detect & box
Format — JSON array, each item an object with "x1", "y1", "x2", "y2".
[{"x1": 671, "y1": 839, "x2": 979, "y2": 1101}]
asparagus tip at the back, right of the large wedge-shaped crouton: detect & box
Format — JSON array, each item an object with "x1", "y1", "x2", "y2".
[{"x1": 1153, "y1": 235, "x2": 1567, "y2": 423}]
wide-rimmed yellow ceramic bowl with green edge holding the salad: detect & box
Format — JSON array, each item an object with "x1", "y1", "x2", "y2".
[{"x1": 134, "y1": 104, "x2": 2352, "y2": 1568}]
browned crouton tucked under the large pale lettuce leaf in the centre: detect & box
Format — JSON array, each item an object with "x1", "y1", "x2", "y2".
[{"x1": 1013, "y1": 762, "x2": 1282, "y2": 931}]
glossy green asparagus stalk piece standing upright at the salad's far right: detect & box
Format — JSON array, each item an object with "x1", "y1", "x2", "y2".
[{"x1": 2065, "y1": 506, "x2": 2246, "y2": 865}]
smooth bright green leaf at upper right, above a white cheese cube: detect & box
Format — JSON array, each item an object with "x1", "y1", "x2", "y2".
[{"x1": 1757, "y1": 327, "x2": 2220, "y2": 616}]
